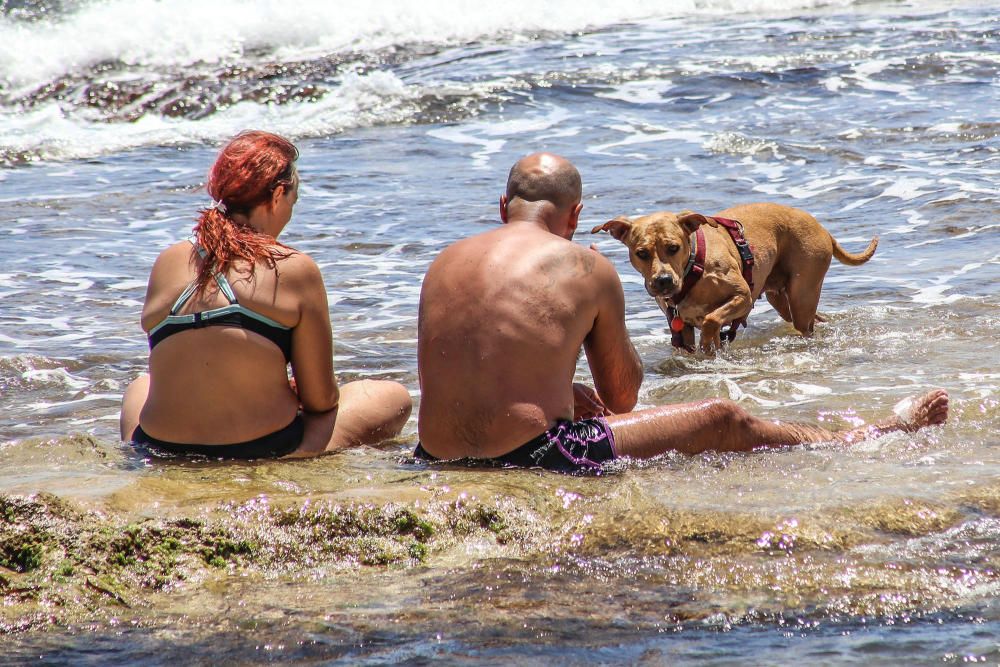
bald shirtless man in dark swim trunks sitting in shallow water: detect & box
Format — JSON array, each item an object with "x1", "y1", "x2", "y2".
[{"x1": 415, "y1": 153, "x2": 948, "y2": 472}]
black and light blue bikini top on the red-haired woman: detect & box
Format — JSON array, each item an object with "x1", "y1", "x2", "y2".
[{"x1": 149, "y1": 241, "x2": 292, "y2": 363}]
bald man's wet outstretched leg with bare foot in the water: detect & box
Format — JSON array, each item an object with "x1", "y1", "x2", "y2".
[{"x1": 607, "y1": 389, "x2": 948, "y2": 459}]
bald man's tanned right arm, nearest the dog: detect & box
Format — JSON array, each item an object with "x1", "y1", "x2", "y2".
[{"x1": 583, "y1": 253, "x2": 642, "y2": 414}]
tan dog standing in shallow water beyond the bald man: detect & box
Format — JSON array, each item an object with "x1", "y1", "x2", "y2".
[{"x1": 591, "y1": 204, "x2": 878, "y2": 352}]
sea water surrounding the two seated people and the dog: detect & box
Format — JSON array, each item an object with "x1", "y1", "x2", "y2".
[{"x1": 0, "y1": 2, "x2": 1000, "y2": 664}]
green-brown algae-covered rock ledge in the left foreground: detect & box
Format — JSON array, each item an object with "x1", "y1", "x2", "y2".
[{"x1": 0, "y1": 494, "x2": 540, "y2": 632}]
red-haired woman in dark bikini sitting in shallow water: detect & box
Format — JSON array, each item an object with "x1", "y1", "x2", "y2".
[{"x1": 121, "y1": 131, "x2": 412, "y2": 459}]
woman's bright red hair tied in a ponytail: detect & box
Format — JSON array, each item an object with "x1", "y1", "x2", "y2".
[{"x1": 194, "y1": 130, "x2": 299, "y2": 291}]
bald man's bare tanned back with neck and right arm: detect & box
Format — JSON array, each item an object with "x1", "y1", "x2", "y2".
[{"x1": 418, "y1": 154, "x2": 642, "y2": 458}]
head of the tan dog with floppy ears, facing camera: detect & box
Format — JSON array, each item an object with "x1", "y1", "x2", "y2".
[{"x1": 590, "y1": 211, "x2": 718, "y2": 298}]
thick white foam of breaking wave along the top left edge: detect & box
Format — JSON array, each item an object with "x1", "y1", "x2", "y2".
[{"x1": 0, "y1": 0, "x2": 888, "y2": 86}]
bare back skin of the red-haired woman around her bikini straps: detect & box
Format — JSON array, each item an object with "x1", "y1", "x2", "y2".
[{"x1": 140, "y1": 241, "x2": 301, "y2": 444}]
